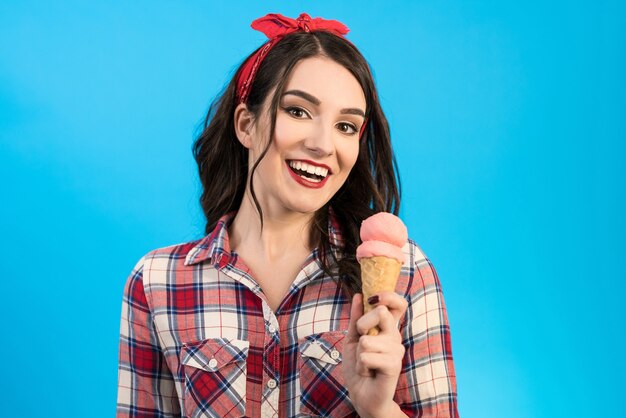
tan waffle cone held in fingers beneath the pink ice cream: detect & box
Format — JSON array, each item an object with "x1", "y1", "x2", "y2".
[{"x1": 360, "y1": 256, "x2": 402, "y2": 335}]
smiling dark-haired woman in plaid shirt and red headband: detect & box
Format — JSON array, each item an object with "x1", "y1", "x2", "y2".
[{"x1": 117, "y1": 14, "x2": 458, "y2": 417}]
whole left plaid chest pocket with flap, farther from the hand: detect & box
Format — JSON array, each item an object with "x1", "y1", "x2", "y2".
[{"x1": 180, "y1": 338, "x2": 250, "y2": 417}]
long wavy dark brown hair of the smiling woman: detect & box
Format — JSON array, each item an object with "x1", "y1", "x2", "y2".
[{"x1": 193, "y1": 31, "x2": 400, "y2": 293}]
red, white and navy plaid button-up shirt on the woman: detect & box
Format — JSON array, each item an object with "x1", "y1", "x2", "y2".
[{"x1": 117, "y1": 213, "x2": 458, "y2": 417}]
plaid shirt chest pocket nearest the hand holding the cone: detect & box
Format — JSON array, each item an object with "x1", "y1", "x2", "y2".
[{"x1": 298, "y1": 331, "x2": 354, "y2": 417}]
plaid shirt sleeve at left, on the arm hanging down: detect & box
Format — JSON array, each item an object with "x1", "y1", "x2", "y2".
[{"x1": 117, "y1": 258, "x2": 180, "y2": 418}]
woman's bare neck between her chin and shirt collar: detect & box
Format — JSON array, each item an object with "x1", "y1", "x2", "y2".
[{"x1": 228, "y1": 196, "x2": 313, "y2": 262}]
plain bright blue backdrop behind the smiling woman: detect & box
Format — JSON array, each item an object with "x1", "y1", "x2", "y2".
[{"x1": 0, "y1": 0, "x2": 626, "y2": 418}]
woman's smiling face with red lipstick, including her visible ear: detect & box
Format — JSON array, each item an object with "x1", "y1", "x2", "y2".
[{"x1": 244, "y1": 57, "x2": 365, "y2": 216}]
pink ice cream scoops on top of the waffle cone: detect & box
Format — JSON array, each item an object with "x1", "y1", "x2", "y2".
[{"x1": 356, "y1": 212, "x2": 408, "y2": 263}]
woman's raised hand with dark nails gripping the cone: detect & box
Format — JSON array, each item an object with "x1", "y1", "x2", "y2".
[{"x1": 343, "y1": 292, "x2": 407, "y2": 417}]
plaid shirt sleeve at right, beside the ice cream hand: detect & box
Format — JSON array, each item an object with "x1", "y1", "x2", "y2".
[{"x1": 396, "y1": 253, "x2": 459, "y2": 418}]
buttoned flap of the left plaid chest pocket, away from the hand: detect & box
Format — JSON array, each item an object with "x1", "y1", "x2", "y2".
[{"x1": 181, "y1": 338, "x2": 250, "y2": 372}]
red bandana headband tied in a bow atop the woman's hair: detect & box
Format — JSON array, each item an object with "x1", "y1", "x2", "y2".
[{"x1": 237, "y1": 13, "x2": 367, "y2": 137}]
